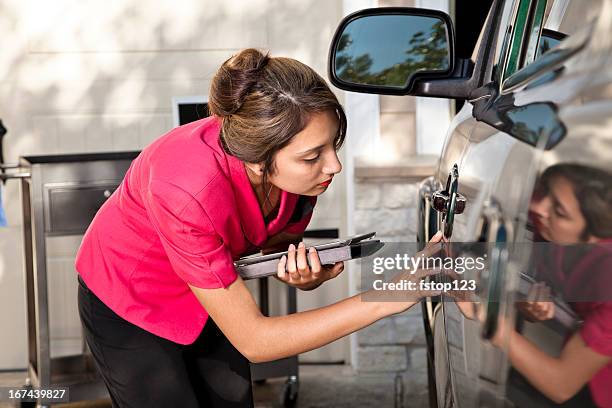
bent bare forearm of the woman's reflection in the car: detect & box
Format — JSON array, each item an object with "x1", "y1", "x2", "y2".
[{"x1": 498, "y1": 330, "x2": 612, "y2": 404}]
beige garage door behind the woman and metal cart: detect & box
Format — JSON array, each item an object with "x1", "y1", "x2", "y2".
[{"x1": 0, "y1": 0, "x2": 345, "y2": 369}]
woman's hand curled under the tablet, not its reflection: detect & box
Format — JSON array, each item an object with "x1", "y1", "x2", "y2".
[{"x1": 276, "y1": 242, "x2": 344, "y2": 290}]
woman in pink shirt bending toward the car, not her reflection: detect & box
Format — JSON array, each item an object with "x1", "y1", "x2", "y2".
[{"x1": 76, "y1": 49, "x2": 440, "y2": 407}]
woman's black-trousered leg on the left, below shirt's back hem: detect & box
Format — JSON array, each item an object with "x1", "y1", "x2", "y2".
[{"x1": 78, "y1": 278, "x2": 199, "y2": 408}]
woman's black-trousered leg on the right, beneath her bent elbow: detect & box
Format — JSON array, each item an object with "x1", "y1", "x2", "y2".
[{"x1": 184, "y1": 318, "x2": 253, "y2": 408}]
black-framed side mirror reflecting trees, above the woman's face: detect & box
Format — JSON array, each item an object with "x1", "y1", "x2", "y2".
[{"x1": 329, "y1": 7, "x2": 454, "y2": 95}]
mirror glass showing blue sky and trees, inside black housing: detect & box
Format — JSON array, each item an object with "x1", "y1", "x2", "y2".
[{"x1": 334, "y1": 14, "x2": 450, "y2": 89}]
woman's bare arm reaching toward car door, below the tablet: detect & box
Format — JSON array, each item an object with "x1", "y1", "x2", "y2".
[{"x1": 191, "y1": 278, "x2": 404, "y2": 363}]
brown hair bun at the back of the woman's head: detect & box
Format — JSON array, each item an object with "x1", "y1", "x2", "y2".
[{"x1": 208, "y1": 48, "x2": 270, "y2": 117}]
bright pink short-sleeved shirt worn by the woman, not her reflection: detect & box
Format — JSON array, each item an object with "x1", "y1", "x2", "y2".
[{"x1": 76, "y1": 117, "x2": 316, "y2": 344}]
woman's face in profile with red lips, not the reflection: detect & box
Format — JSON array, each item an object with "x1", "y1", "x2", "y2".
[{"x1": 268, "y1": 111, "x2": 342, "y2": 196}]
